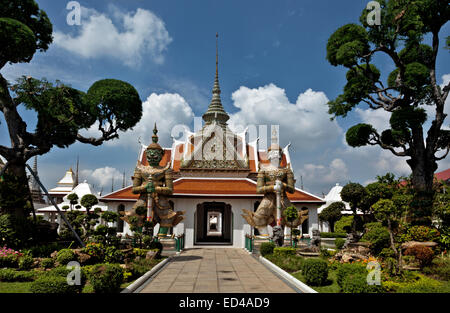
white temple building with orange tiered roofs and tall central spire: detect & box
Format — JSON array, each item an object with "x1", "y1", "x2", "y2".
[{"x1": 99, "y1": 40, "x2": 325, "y2": 248}]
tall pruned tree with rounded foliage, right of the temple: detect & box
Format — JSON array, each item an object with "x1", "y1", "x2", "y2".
[{"x1": 327, "y1": 0, "x2": 450, "y2": 195}]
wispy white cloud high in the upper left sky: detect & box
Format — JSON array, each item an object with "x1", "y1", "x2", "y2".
[{"x1": 53, "y1": 8, "x2": 172, "y2": 66}]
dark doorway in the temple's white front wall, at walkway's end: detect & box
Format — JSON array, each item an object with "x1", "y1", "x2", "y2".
[{"x1": 194, "y1": 202, "x2": 233, "y2": 245}]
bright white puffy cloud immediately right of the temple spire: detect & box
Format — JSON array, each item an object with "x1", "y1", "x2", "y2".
[{"x1": 229, "y1": 84, "x2": 342, "y2": 151}]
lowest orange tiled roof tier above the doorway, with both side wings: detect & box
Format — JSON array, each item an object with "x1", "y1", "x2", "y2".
[{"x1": 101, "y1": 178, "x2": 324, "y2": 203}]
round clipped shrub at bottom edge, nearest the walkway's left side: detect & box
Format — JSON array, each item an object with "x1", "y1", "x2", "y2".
[{"x1": 89, "y1": 264, "x2": 124, "y2": 293}]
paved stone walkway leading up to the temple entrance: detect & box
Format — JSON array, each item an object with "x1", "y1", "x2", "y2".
[{"x1": 141, "y1": 248, "x2": 296, "y2": 293}]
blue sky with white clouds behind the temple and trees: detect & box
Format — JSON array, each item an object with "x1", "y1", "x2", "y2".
[{"x1": 0, "y1": 0, "x2": 450, "y2": 195}]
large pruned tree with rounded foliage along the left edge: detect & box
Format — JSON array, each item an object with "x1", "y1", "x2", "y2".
[{"x1": 0, "y1": 0, "x2": 142, "y2": 216}]
